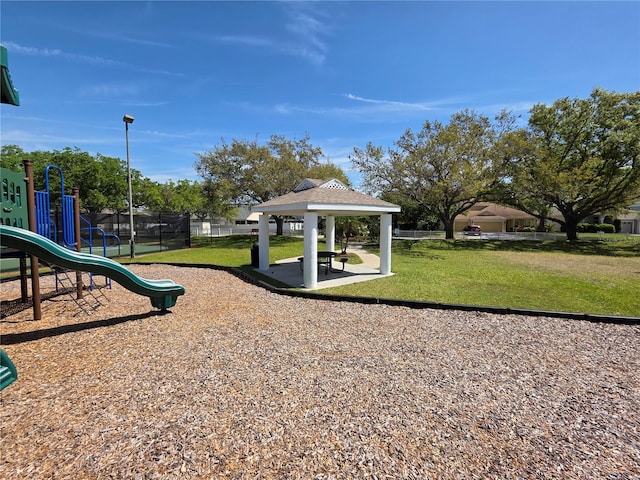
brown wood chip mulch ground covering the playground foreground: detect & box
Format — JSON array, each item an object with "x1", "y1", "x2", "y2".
[{"x1": 0, "y1": 265, "x2": 640, "y2": 479}]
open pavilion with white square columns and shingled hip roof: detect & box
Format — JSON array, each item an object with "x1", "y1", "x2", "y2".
[{"x1": 251, "y1": 178, "x2": 400, "y2": 289}]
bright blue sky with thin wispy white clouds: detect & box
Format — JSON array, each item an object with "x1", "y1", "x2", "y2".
[{"x1": 0, "y1": 0, "x2": 640, "y2": 186}]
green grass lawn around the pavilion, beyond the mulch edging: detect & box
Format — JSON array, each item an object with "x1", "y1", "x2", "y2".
[{"x1": 125, "y1": 236, "x2": 640, "y2": 316}]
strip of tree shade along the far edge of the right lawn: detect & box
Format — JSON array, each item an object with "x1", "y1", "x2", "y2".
[{"x1": 393, "y1": 239, "x2": 640, "y2": 257}]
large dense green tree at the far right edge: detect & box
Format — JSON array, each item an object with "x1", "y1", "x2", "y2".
[{"x1": 504, "y1": 88, "x2": 640, "y2": 240}]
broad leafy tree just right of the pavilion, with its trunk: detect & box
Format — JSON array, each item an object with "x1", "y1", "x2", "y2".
[{"x1": 351, "y1": 110, "x2": 510, "y2": 238}]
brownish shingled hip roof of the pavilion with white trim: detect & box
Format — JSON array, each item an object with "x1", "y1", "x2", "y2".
[{"x1": 251, "y1": 178, "x2": 400, "y2": 216}]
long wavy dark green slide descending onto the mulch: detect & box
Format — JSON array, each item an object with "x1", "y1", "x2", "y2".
[{"x1": 0, "y1": 225, "x2": 184, "y2": 310}]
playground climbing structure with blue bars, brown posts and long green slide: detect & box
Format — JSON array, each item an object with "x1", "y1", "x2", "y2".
[{"x1": 0, "y1": 161, "x2": 184, "y2": 320}]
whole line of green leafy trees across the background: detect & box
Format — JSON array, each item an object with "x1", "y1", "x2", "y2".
[{"x1": 2, "y1": 88, "x2": 640, "y2": 240}]
